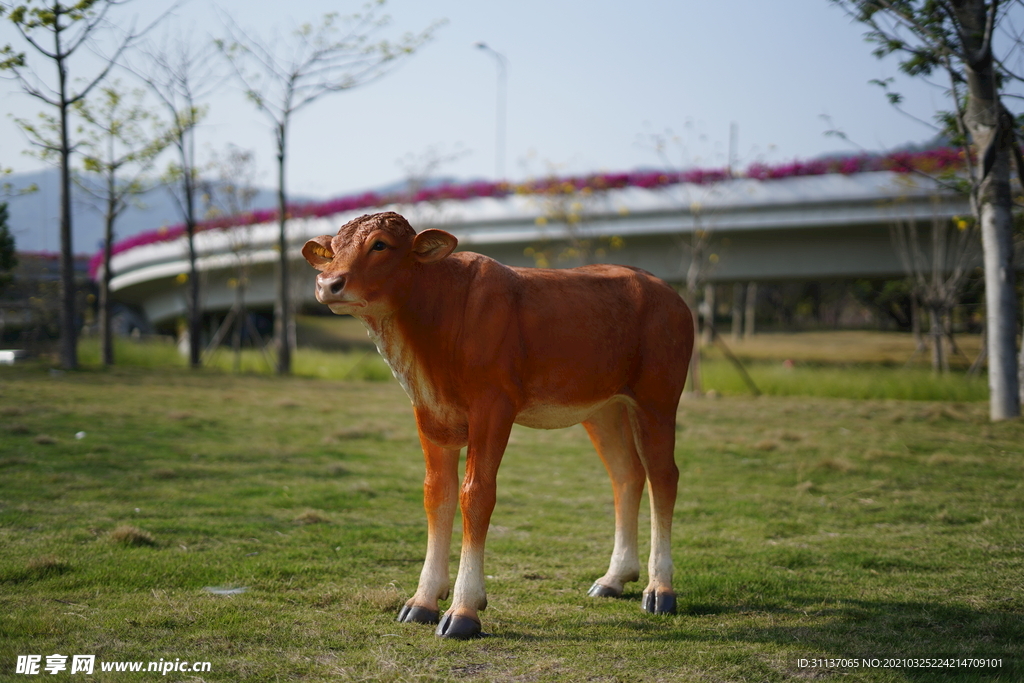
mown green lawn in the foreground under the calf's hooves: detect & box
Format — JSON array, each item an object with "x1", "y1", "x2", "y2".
[{"x1": 0, "y1": 356, "x2": 1024, "y2": 682}]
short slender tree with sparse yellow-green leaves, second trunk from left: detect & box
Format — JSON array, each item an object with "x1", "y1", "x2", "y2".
[{"x1": 75, "y1": 84, "x2": 170, "y2": 366}]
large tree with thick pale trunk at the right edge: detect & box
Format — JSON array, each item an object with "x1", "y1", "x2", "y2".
[{"x1": 833, "y1": 0, "x2": 1024, "y2": 420}]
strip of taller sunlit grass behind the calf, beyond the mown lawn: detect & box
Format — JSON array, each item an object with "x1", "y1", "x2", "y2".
[{"x1": 80, "y1": 325, "x2": 988, "y2": 402}]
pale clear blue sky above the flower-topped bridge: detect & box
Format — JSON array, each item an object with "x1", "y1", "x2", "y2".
[{"x1": 0, "y1": 0, "x2": 944, "y2": 197}]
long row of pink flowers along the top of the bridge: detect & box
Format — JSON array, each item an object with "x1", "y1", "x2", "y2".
[{"x1": 89, "y1": 148, "x2": 963, "y2": 279}]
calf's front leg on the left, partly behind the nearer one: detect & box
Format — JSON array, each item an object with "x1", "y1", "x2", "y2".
[{"x1": 398, "y1": 432, "x2": 459, "y2": 624}]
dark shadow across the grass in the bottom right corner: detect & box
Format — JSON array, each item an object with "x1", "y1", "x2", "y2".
[{"x1": 477, "y1": 592, "x2": 1024, "y2": 681}]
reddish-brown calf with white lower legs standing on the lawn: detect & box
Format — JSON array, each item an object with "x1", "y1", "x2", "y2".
[{"x1": 302, "y1": 212, "x2": 693, "y2": 638}]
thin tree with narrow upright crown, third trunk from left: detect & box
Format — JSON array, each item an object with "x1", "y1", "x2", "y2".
[{"x1": 129, "y1": 35, "x2": 223, "y2": 368}]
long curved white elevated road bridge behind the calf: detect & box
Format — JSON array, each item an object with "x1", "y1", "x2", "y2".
[{"x1": 103, "y1": 171, "x2": 970, "y2": 328}]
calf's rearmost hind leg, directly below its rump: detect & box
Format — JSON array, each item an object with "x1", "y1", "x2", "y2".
[{"x1": 630, "y1": 407, "x2": 679, "y2": 614}]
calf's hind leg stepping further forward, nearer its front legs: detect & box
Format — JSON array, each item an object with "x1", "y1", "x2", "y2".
[{"x1": 583, "y1": 401, "x2": 644, "y2": 597}]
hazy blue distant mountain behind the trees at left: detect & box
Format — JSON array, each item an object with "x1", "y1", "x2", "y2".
[{"x1": 4, "y1": 169, "x2": 321, "y2": 255}]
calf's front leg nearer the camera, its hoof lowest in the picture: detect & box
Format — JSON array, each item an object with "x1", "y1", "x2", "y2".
[{"x1": 436, "y1": 403, "x2": 514, "y2": 639}]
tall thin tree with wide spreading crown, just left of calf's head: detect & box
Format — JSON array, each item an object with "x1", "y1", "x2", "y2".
[{"x1": 217, "y1": 0, "x2": 438, "y2": 375}]
